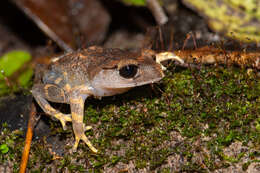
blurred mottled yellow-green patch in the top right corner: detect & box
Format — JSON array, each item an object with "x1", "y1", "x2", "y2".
[{"x1": 182, "y1": 0, "x2": 260, "y2": 42}]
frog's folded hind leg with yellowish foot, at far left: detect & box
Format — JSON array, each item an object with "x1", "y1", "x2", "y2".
[{"x1": 32, "y1": 84, "x2": 71, "y2": 130}]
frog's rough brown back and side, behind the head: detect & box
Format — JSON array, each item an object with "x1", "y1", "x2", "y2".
[{"x1": 45, "y1": 46, "x2": 141, "y2": 87}]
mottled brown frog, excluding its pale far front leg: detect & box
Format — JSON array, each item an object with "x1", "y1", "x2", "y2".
[{"x1": 32, "y1": 46, "x2": 163, "y2": 152}]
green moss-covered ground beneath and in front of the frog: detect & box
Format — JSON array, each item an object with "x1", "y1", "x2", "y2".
[{"x1": 0, "y1": 66, "x2": 260, "y2": 173}]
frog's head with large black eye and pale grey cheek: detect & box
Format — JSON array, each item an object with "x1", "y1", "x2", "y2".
[{"x1": 92, "y1": 48, "x2": 164, "y2": 96}]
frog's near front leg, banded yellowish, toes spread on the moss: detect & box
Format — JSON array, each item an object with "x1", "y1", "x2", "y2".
[{"x1": 70, "y1": 94, "x2": 97, "y2": 153}]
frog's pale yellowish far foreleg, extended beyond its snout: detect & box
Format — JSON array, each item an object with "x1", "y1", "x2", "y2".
[{"x1": 156, "y1": 52, "x2": 184, "y2": 70}]
